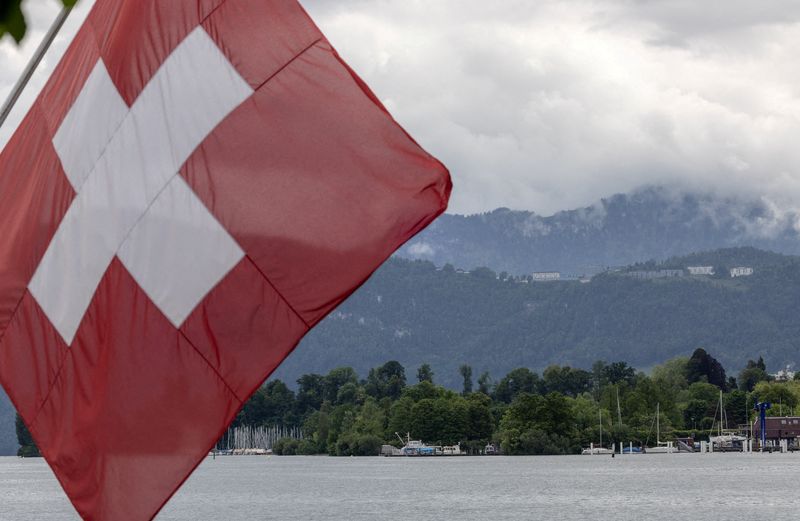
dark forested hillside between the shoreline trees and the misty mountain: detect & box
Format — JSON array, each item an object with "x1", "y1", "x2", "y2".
[{"x1": 277, "y1": 248, "x2": 800, "y2": 387}]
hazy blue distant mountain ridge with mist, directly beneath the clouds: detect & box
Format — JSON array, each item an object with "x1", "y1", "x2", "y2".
[{"x1": 398, "y1": 188, "x2": 800, "y2": 275}]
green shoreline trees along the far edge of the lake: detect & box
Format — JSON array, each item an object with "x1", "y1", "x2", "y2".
[{"x1": 17, "y1": 349, "x2": 800, "y2": 456}]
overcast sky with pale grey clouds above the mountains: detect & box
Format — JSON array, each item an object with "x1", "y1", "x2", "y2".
[{"x1": 0, "y1": 0, "x2": 800, "y2": 214}]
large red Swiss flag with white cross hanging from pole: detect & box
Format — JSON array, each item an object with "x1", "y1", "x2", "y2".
[{"x1": 0, "y1": 0, "x2": 451, "y2": 520}]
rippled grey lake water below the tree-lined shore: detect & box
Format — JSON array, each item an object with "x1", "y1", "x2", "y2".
[{"x1": 0, "y1": 454, "x2": 800, "y2": 521}]
